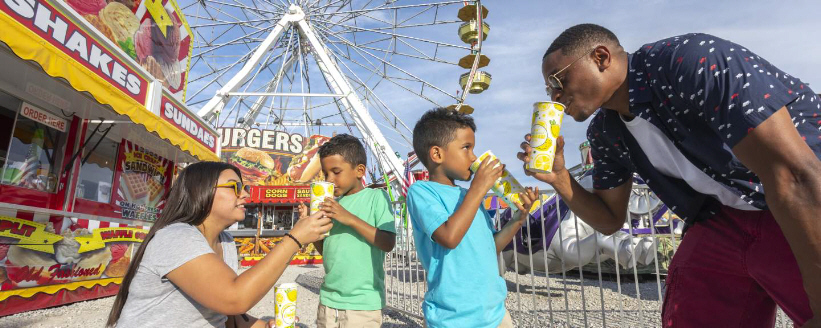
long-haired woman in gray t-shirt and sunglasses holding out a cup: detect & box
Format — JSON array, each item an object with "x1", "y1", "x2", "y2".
[{"x1": 106, "y1": 162, "x2": 331, "y2": 327}]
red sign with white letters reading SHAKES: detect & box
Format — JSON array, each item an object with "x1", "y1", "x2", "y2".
[{"x1": 0, "y1": 0, "x2": 148, "y2": 104}]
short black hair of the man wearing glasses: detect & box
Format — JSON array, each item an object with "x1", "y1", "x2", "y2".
[{"x1": 542, "y1": 24, "x2": 621, "y2": 60}]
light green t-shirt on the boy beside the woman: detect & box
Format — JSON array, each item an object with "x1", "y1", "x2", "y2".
[{"x1": 319, "y1": 188, "x2": 396, "y2": 310}]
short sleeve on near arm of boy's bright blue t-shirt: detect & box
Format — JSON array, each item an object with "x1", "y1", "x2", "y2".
[{"x1": 408, "y1": 184, "x2": 450, "y2": 240}]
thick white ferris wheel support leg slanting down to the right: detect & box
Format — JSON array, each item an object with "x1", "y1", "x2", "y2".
[{"x1": 295, "y1": 12, "x2": 407, "y2": 191}]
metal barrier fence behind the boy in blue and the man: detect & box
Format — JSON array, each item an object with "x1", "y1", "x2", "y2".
[{"x1": 385, "y1": 186, "x2": 792, "y2": 327}]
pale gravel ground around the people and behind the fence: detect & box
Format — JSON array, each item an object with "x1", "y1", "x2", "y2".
[{"x1": 0, "y1": 263, "x2": 792, "y2": 328}]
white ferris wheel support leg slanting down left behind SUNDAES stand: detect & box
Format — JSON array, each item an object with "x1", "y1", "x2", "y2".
[{"x1": 197, "y1": 10, "x2": 305, "y2": 121}]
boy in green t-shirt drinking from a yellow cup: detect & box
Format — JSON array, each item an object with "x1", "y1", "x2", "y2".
[{"x1": 299, "y1": 134, "x2": 396, "y2": 328}]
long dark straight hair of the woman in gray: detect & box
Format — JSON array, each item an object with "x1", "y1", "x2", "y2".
[{"x1": 106, "y1": 162, "x2": 242, "y2": 327}]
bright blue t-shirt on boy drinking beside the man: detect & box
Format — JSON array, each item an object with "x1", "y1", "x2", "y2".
[{"x1": 408, "y1": 181, "x2": 507, "y2": 328}]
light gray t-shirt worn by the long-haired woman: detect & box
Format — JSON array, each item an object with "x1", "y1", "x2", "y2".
[{"x1": 117, "y1": 223, "x2": 238, "y2": 328}]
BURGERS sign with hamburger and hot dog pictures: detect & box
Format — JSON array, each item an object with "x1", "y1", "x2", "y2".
[{"x1": 218, "y1": 128, "x2": 330, "y2": 186}]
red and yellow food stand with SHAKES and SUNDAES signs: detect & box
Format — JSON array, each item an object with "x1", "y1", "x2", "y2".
[{"x1": 0, "y1": 0, "x2": 219, "y2": 316}]
